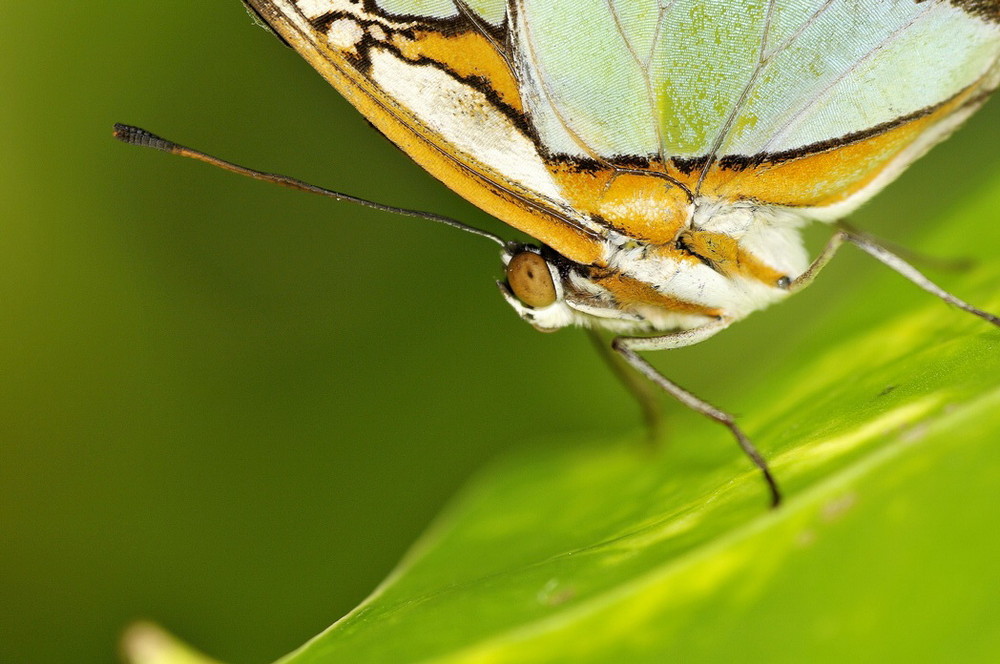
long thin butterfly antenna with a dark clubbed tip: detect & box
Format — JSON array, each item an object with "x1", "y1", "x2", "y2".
[{"x1": 114, "y1": 123, "x2": 507, "y2": 247}]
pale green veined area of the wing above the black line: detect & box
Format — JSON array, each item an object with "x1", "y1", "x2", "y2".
[{"x1": 512, "y1": 0, "x2": 1000, "y2": 159}]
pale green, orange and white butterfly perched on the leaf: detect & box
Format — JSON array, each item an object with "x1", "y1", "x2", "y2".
[{"x1": 117, "y1": 0, "x2": 1000, "y2": 505}]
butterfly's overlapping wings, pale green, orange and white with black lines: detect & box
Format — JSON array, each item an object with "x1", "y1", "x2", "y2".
[{"x1": 247, "y1": 0, "x2": 1000, "y2": 255}]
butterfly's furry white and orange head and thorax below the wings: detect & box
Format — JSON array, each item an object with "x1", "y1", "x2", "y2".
[{"x1": 501, "y1": 201, "x2": 808, "y2": 334}]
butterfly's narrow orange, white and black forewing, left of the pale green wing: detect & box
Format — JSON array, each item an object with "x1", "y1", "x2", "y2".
[{"x1": 247, "y1": 0, "x2": 612, "y2": 263}]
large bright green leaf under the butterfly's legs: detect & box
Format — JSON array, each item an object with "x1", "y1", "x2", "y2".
[{"x1": 266, "y1": 174, "x2": 1000, "y2": 664}]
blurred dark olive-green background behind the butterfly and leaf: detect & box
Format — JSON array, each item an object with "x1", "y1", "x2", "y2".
[{"x1": 0, "y1": 5, "x2": 1000, "y2": 663}]
